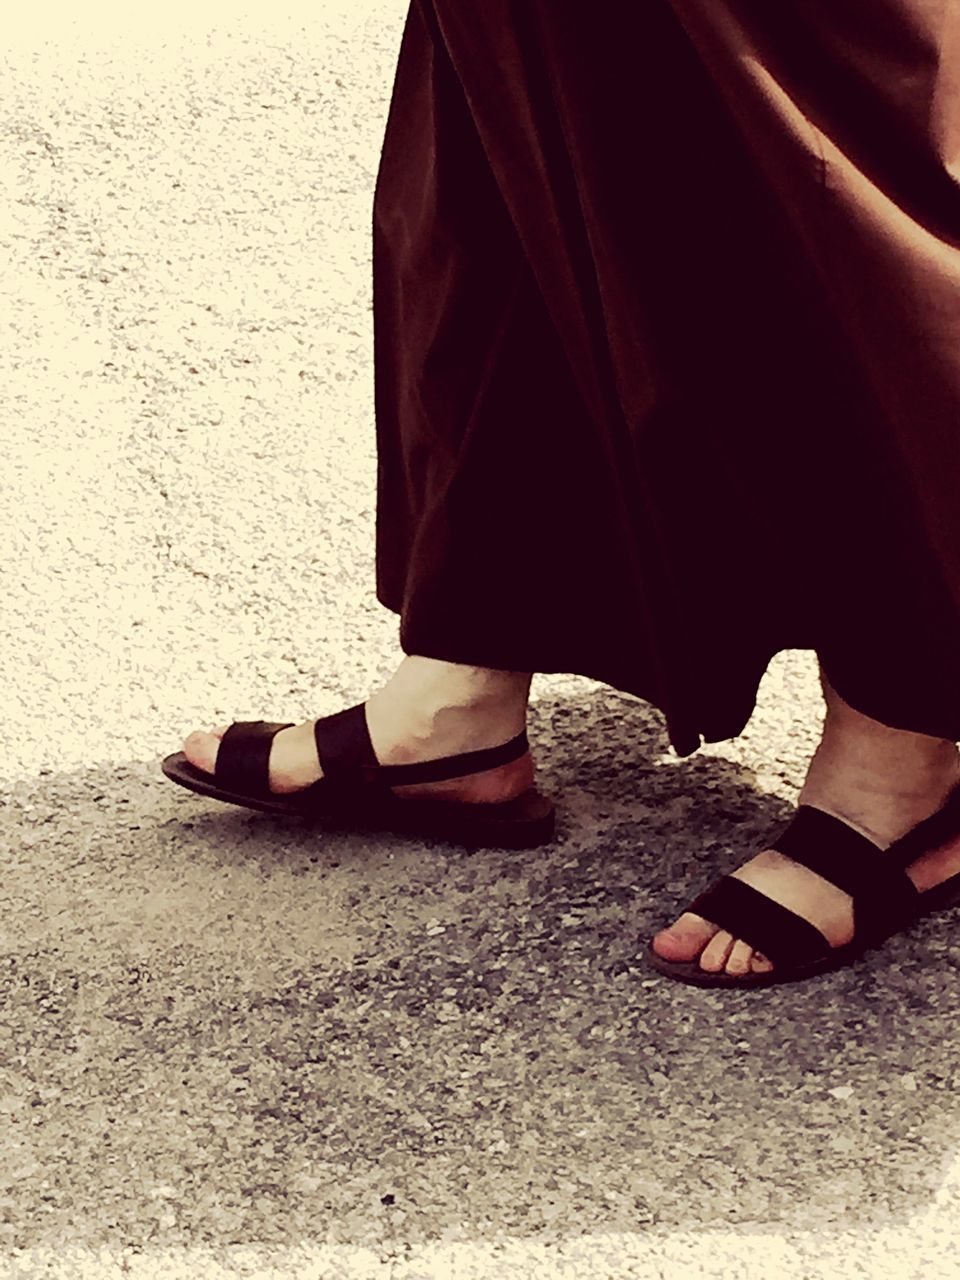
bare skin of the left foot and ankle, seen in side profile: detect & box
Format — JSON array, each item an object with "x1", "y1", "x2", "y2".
[{"x1": 183, "y1": 655, "x2": 535, "y2": 803}]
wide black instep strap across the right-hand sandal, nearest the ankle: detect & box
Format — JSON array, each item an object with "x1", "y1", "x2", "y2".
[{"x1": 769, "y1": 805, "x2": 919, "y2": 942}]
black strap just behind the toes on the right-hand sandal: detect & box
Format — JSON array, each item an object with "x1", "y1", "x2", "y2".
[{"x1": 686, "y1": 876, "x2": 831, "y2": 969}]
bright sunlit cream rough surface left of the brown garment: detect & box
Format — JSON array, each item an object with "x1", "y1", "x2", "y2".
[{"x1": 0, "y1": 0, "x2": 406, "y2": 776}]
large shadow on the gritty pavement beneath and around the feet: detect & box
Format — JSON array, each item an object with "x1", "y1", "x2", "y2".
[{"x1": 0, "y1": 690, "x2": 960, "y2": 1248}]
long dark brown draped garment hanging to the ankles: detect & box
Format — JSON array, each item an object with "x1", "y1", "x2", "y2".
[{"x1": 372, "y1": 0, "x2": 960, "y2": 755}]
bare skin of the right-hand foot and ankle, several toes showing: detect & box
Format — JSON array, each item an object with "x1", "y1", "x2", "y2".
[{"x1": 654, "y1": 666, "x2": 960, "y2": 974}]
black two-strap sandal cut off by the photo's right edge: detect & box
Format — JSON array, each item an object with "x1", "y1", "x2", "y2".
[{"x1": 646, "y1": 785, "x2": 960, "y2": 988}]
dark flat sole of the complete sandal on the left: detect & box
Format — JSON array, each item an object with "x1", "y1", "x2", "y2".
[{"x1": 160, "y1": 751, "x2": 557, "y2": 849}]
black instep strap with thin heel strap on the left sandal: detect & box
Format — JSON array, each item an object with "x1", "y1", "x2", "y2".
[{"x1": 314, "y1": 703, "x2": 530, "y2": 787}]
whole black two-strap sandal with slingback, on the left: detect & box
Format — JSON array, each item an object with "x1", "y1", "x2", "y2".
[{"x1": 161, "y1": 703, "x2": 556, "y2": 849}]
